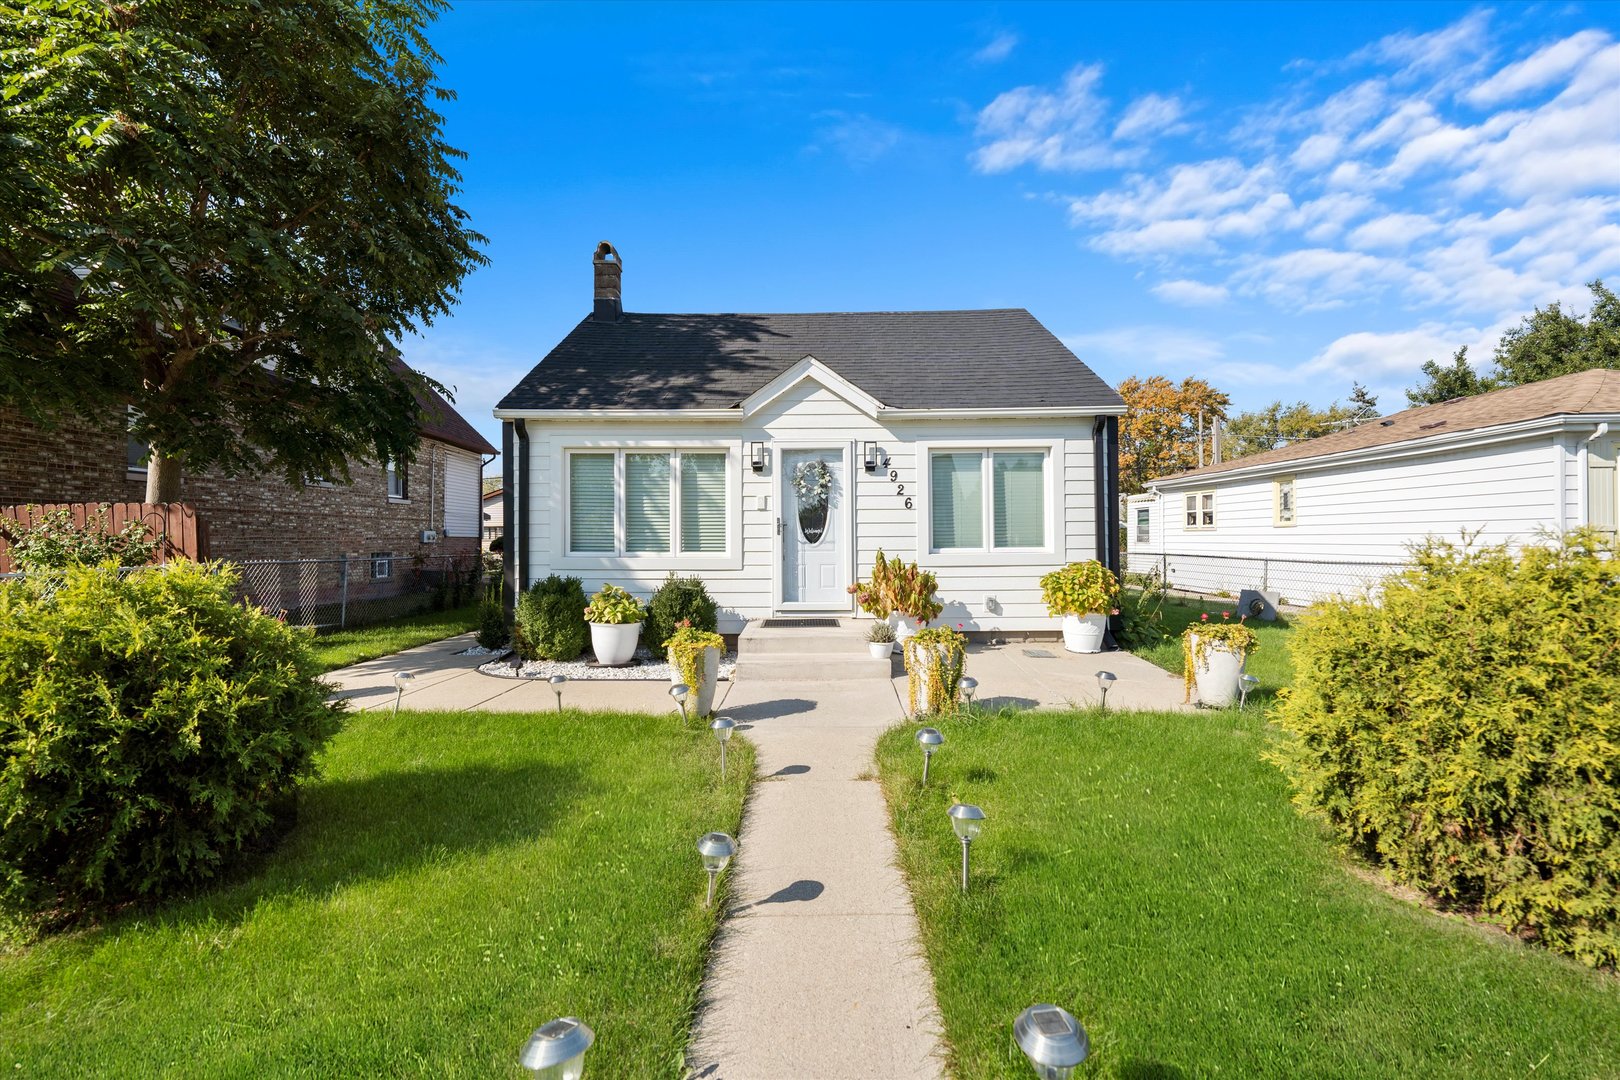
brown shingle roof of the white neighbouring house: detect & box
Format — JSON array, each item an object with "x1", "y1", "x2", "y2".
[{"x1": 1152, "y1": 368, "x2": 1620, "y2": 484}]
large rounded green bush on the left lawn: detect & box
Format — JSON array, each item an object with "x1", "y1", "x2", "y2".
[{"x1": 0, "y1": 563, "x2": 342, "y2": 926}]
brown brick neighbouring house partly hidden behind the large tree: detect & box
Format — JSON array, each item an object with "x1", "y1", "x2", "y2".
[{"x1": 0, "y1": 378, "x2": 496, "y2": 578}]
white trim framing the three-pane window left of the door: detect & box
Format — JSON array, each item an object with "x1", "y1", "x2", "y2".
[{"x1": 546, "y1": 436, "x2": 744, "y2": 573}]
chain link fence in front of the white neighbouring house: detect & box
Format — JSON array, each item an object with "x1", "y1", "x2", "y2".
[{"x1": 1126, "y1": 552, "x2": 1408, "y2": 607}]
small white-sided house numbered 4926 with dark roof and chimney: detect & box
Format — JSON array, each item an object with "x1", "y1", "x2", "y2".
[{"x1": 496, "y1": 243, "x2": 1124, "y2": 631}]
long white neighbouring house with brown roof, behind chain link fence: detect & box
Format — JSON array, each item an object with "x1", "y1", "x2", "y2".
[{"x1": 1126, "y1": 371, "x2": 1620, "y2": 601}]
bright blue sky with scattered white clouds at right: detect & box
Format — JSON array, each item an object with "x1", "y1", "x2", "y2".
[{"x1": 405, "y1": 3, "x2": 1620, "y2": 459}]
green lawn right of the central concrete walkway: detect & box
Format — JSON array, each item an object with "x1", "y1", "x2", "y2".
[{"x1": 878, "y1": 711, "x2": 1620, "y2": 1080}]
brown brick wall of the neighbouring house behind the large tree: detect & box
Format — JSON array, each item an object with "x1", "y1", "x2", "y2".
[{"x1": 0, "y1": 410, "x2": 480, "y2": 560}]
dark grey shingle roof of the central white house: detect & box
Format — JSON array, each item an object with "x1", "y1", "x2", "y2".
[{"x1": 497, "y1": 308, "x2": 1123, "y2": 410}]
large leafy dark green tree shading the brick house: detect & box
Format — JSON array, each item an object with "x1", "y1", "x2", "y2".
[{"x1": 0, "y1": 0, "x2": 484, "y2": 502}]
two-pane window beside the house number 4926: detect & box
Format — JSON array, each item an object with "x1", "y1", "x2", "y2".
[{"x1": 928, "y1": 450, "x2": 1047, "y2": 551}]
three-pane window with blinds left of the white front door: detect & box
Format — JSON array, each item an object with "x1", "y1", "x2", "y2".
[{"x1": 567, "y1": 450, "x2": 727, "y2": 555}]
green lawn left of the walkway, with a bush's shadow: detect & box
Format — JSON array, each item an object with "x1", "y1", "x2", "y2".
[{"x1": 0, "y1": 711, "x2": 753, "y2": 1078}]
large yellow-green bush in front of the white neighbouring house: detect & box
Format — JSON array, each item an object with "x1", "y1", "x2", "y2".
[{"x1": 1268, "y1": 531, "x2": 1620, "y2": 967}]
